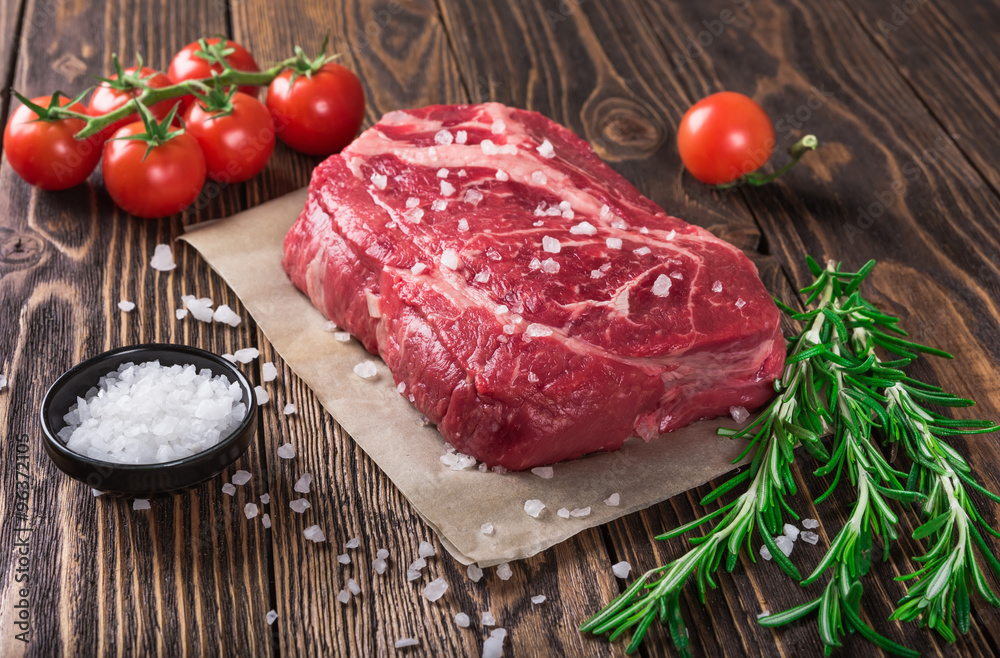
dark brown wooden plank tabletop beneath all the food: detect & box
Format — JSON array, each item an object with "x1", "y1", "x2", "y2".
[{"x1": 0, "y1": 0, "x2": 1000, "y2": 656}]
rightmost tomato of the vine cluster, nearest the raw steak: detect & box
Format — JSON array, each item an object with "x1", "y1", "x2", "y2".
[{"x1": 267, "y1": 62, "x2": 365, "y2": 155}]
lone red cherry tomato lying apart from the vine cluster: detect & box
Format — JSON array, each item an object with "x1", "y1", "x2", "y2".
[{"x1": 677, "y1": 91, "x2": 774, "y2": 185}]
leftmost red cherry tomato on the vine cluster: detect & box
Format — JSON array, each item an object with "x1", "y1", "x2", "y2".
[{"x1": 3, "y1": 96, "x2": 104, "y2": 190}]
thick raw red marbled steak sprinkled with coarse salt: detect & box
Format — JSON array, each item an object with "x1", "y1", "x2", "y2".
[{"x1": 284, "y1": 103, "x2": 785, "y2": 470}]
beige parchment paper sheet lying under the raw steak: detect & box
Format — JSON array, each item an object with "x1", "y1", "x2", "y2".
[{"x1": 181, "y1": 189, "x2": 745, "y2": 567}]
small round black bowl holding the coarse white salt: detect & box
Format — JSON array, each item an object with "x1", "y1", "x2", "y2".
[{"x1": 41, "y1": 343, "x2": 257, "y2": 496}]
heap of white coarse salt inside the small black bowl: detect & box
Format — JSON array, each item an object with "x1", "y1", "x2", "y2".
[{"x1": 59, "y1": 361, "x2": 246, "y2": 464}]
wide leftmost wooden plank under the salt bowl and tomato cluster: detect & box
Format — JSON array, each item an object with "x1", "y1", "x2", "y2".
[{"x1": 0, "y1": 0, "x2": 272, "y2": 655}]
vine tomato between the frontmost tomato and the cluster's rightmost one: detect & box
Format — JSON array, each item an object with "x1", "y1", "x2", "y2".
[{"x1": 184, "y1": 92, "x2": 274, "y2": 183}]
